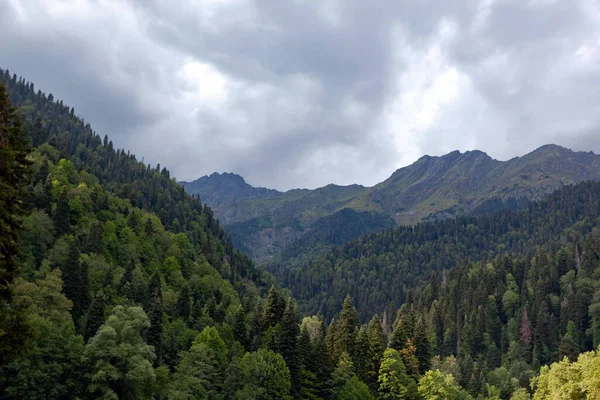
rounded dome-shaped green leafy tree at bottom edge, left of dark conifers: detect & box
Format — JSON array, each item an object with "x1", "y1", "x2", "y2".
[{"x1": 235, "y1": 349, "x2": 291, "y2": 400}]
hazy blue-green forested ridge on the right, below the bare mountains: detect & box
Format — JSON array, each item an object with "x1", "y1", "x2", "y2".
[{"x1": 267, "y1": 182, "x2": 600, "y2": 321}]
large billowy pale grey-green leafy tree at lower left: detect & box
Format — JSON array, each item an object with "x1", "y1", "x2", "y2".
[{"x1": 83, "y1": 306, "x2": 156, "y2": 399}]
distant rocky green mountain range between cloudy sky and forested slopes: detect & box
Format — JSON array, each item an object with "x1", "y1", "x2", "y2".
[{"x1": 180, "y1": 145, "x2": 600, "y2": 262}]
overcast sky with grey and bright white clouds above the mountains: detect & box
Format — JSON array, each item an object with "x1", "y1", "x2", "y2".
[{"x1": 0, "y1": 0, "x2": 600, "y2": 189}]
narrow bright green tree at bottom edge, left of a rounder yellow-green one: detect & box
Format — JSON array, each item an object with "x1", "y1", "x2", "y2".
[{"x1": 378, "y1": 348, "x2": 418, "y2": 399}]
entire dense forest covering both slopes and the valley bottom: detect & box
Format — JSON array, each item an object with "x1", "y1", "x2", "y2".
[{"x1": 0, "y1": 70, "x2": 600, "y2": 400}]
